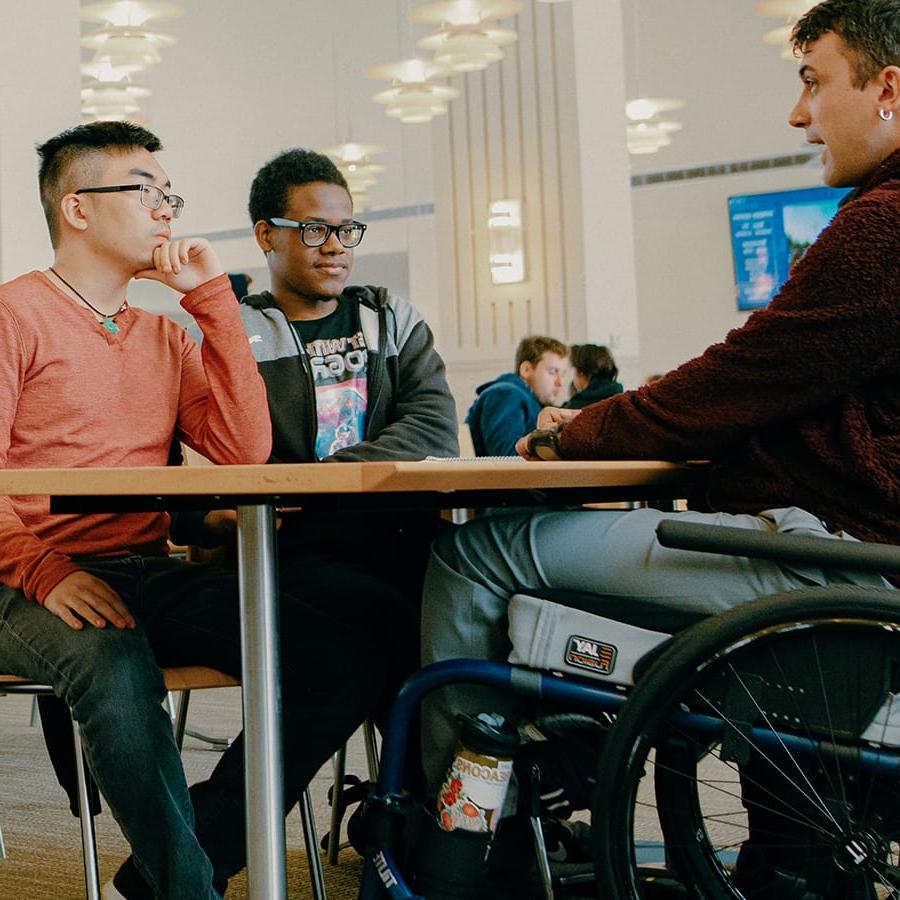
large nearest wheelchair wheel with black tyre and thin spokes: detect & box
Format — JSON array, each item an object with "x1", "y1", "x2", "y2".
[{"x1": 593, "y1": 586, "x2": 900, "y2": 900}]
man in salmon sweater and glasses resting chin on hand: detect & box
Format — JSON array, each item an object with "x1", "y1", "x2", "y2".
[{"x1": 0, "y1": 122, "x2": 377, "y2": 900}]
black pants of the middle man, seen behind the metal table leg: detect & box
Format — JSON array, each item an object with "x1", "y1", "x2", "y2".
[{"x1": 191, "y1": 555, "x2": 398, "y2": 883}]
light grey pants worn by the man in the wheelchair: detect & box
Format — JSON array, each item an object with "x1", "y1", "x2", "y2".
[{"x1": 422, "y1": 508, "x2": 886, "y2": 790}]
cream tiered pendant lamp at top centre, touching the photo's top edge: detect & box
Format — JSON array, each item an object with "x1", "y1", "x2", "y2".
[{"x1": 409, "y1": 0, "x2": 522, "y2": 72}]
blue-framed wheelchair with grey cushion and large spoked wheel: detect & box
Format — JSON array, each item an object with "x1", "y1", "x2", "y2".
[{"x1": 360, "y1": 520, "x2": 900, "y2": 900}]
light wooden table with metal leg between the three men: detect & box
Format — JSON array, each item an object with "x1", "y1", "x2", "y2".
[{"x1": 0, "y1": 459, "x2": 702, "y2": 900}]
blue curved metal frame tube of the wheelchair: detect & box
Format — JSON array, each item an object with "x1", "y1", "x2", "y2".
[{"x1": 359, "y1": 659, "x2": 900, "y2": 900}]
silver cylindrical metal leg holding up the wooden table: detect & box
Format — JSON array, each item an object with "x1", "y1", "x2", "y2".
[{"x1": 238, "y1": 504, "x2": 287, "y2": 900}]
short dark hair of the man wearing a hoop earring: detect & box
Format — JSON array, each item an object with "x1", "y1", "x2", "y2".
[{"x1": 791, "y1": 0, "x2": 900, "y2": 88}]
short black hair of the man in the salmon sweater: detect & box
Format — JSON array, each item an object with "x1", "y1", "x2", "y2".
[{"x1": 37, "y1": 122, "x2": 162, "y2": 247}]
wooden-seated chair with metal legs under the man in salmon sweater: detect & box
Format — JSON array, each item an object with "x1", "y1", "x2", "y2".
[{"x1": 0, "y1": 666, "x2": 327, "y2": 900}]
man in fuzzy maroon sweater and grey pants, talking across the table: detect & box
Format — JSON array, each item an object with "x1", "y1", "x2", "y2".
[{"x1": 423, "y1": 0, "x2": 900, "y2": 892}]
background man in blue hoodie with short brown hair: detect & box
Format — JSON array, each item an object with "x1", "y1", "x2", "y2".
[{"x1": 466, "y1": 335, "x2": 568, "y2": 456}]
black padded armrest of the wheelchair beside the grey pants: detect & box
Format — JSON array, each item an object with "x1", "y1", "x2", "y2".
[{"x1": 656, "y1": 519, "x2": 900, "y2": 573}]
